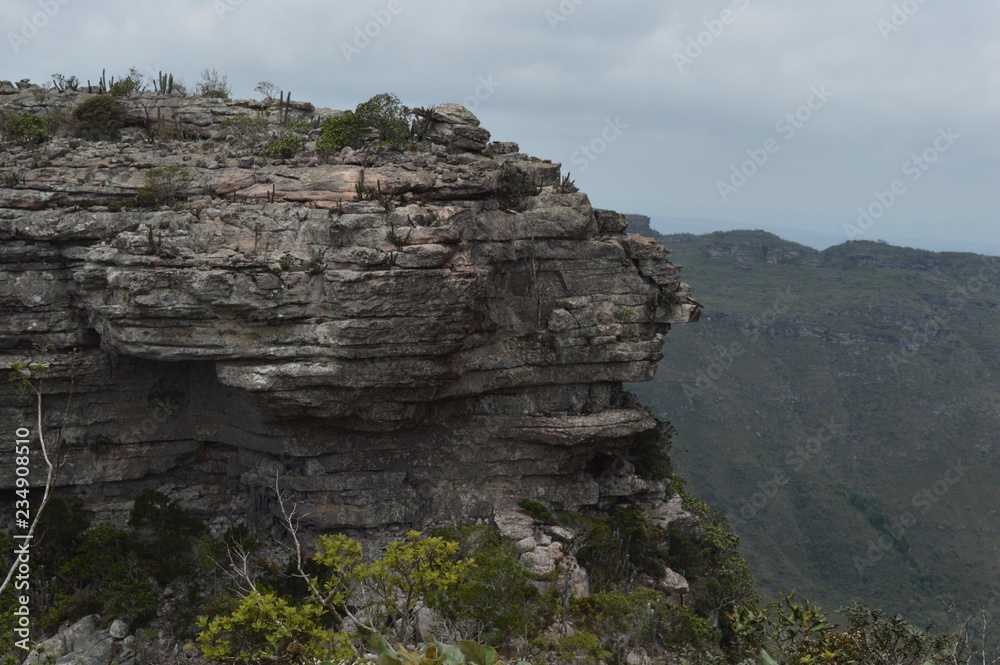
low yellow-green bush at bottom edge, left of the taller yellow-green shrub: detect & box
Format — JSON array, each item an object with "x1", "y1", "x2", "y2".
[{"x1": 195, "y1": 589, "x2": 354, "y2": 665}]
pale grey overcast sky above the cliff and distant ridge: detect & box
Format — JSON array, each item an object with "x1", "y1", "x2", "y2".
[{"x1": 0, "y1": 0, "x2": 1000, "y2": 254}]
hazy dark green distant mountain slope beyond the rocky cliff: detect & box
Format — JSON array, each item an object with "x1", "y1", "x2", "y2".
[{"x1": 629, "y1": 222, "x2": 1000, "y2": 620}]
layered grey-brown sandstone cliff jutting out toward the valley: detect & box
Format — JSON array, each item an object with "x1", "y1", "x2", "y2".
[{"x1": 0, "y1": 88, "x2": 697, "y2": 530}]
